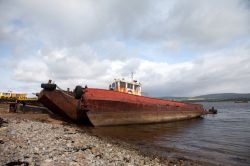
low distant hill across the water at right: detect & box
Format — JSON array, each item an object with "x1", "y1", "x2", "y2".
[{"x1": 162, "y1": 93, "x2": 250, "y2": 101}]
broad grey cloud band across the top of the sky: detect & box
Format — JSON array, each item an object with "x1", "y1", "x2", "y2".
[{"x1": 0, "y1": 0, "x2": 250, "y2": 48}]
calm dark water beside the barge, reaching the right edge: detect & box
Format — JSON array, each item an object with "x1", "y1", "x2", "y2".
[{"x1": 88, "y1": 102, "x2": 250, "y2": 165}]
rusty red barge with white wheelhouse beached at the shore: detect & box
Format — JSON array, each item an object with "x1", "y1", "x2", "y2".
[{"x1": 38, "y1": 79, "x2": 208, "y2": 126}]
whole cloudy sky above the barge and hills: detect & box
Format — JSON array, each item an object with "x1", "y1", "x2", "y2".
[{"x1": 0, "y1": 0, "x2": 250, "y2": 96}]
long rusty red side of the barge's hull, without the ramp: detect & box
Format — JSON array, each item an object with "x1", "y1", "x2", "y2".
[{"x1": 81, "y1": 88, "x2": 207, "y2": 126}]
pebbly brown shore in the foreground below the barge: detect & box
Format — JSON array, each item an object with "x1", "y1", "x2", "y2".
[{"x1": 0, "y1": 110, "x2": 211, "y2": 165}]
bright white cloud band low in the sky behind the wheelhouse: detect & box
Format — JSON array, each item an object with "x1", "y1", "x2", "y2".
[{"x1": 11, "y1": 43, "x2": 250, "y2": 96}]
